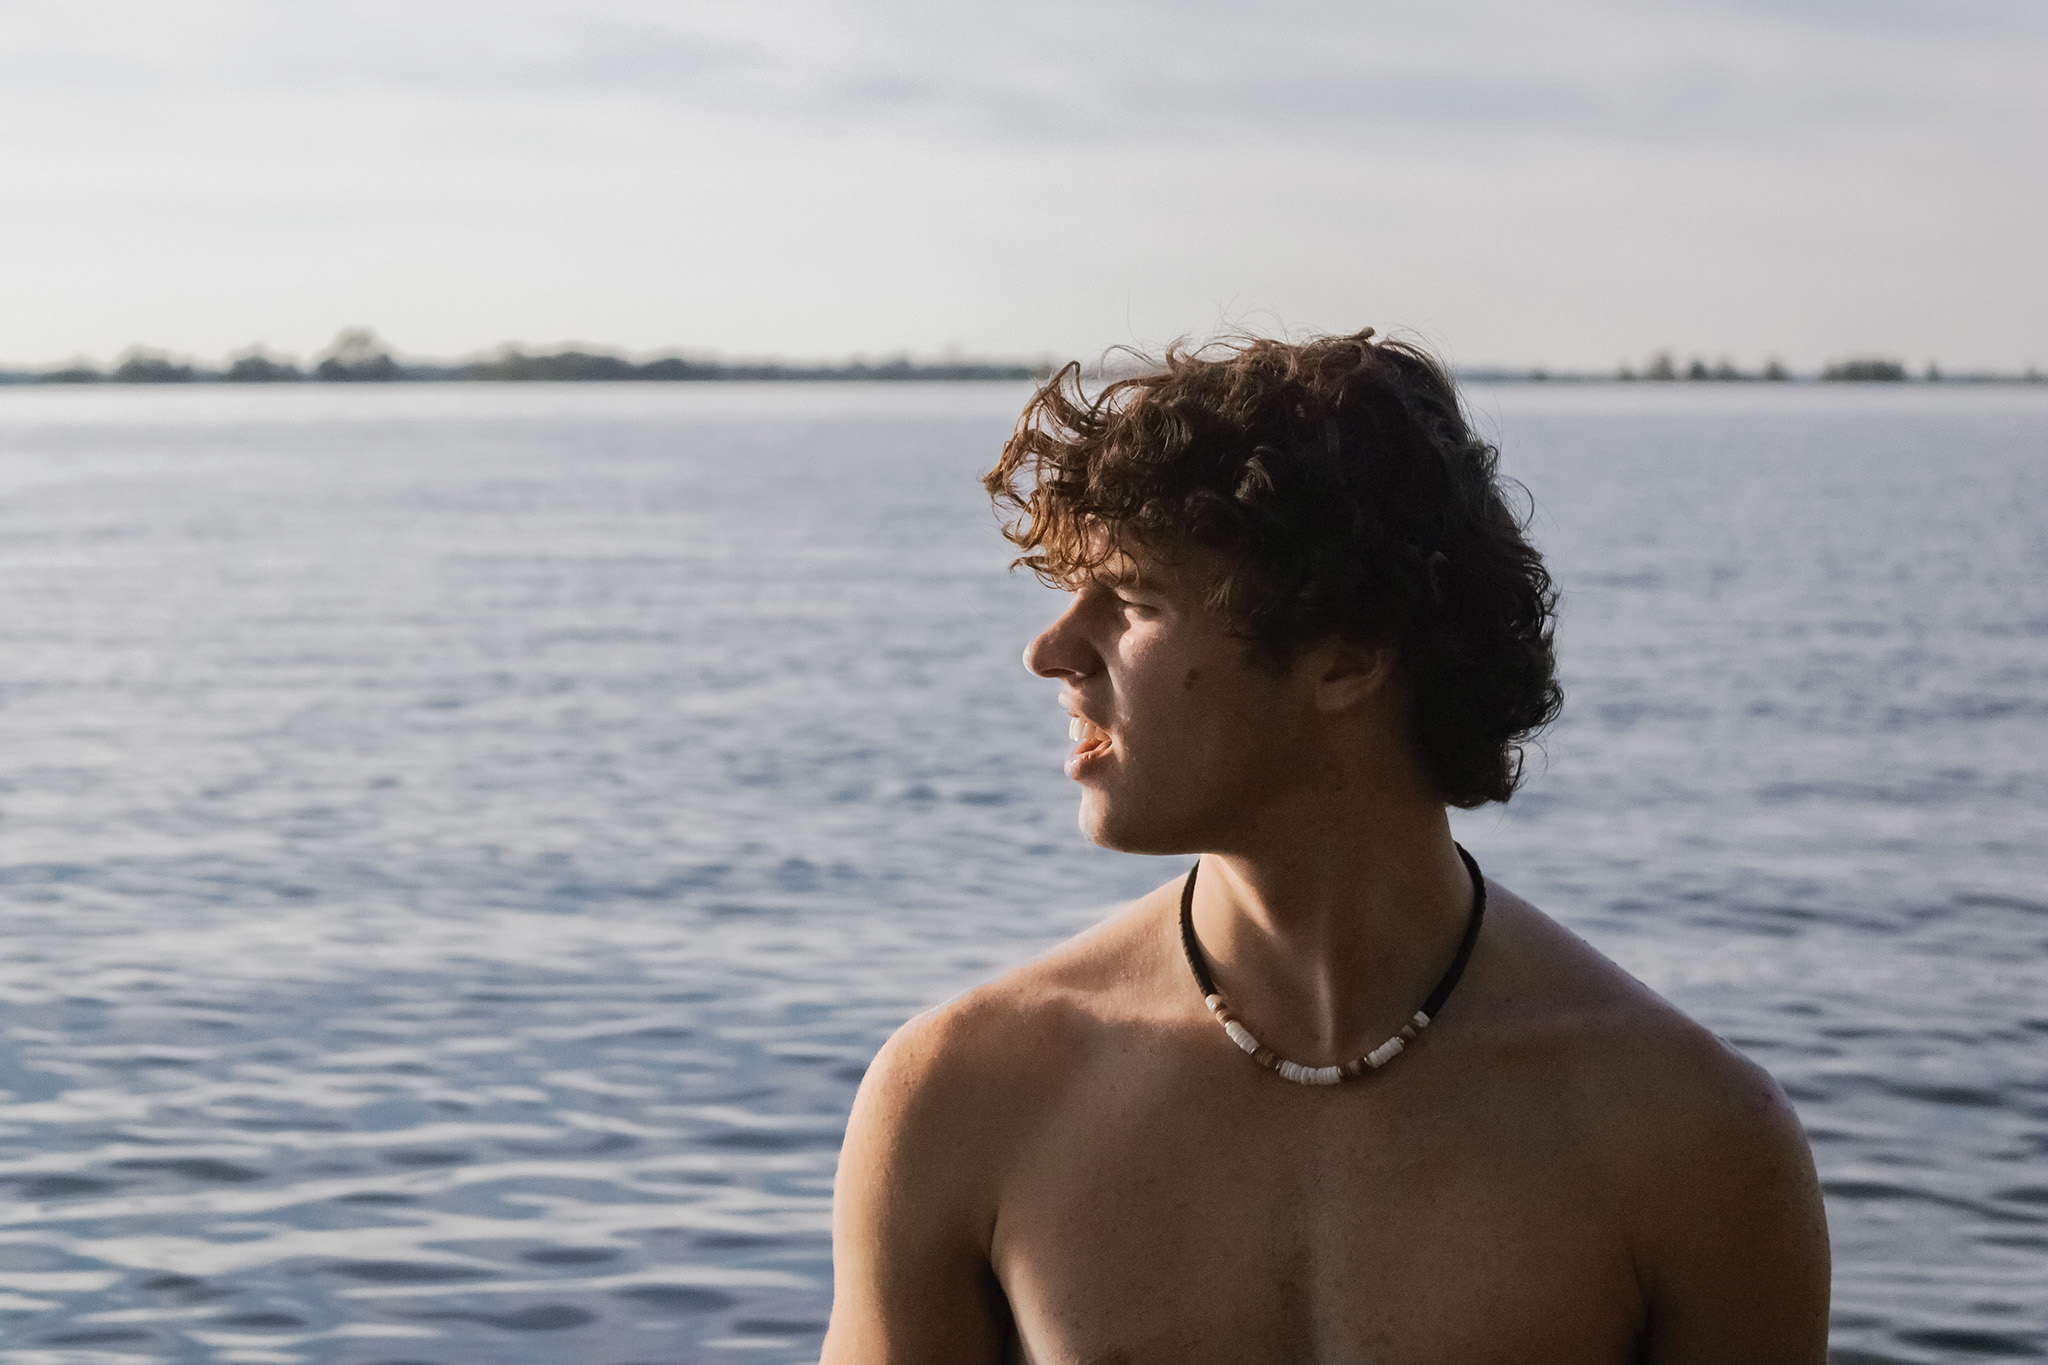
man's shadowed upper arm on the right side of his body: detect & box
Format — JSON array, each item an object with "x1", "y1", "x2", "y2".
[{"x1": 1638, "y1": 1056, "x2": 1829, "y2": 1365}]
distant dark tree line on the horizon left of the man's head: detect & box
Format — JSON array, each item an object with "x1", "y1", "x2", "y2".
[{"x1": 10, "y1": 327, "x2": 1053, "y2": 385}]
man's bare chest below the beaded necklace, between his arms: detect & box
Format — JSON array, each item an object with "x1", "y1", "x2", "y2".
[{"x1": 991, "y1": 1072, "x2": 1640, "y2": 1365}]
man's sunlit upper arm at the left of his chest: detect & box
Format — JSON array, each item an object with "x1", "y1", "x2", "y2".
[{"x1": 823, "y1": 1007, "x2": 1008, "y2": 1365}]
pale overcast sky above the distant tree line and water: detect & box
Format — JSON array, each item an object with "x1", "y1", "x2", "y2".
[{"x1": 0, "y1": 0, "x2": 2048, "y2": 368}]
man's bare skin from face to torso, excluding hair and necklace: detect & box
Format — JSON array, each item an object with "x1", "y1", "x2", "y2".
[{"x1": 825, "y1": 555, "x2": 1827, "y2": 1365}]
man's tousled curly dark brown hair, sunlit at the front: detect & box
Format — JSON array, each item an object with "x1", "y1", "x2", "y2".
[{"x1": 983, "y1": 327, "x2": 1563, "y2": 808}]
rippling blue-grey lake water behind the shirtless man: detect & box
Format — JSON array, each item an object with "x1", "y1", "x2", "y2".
[{"x1": 0, "y1": 385, "x2": 2048, "y2": 1365}]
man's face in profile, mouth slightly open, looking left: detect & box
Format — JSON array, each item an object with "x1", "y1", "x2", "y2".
[{"x1": 1024, "y1": 551, "x2": 1313, "y2": 853}]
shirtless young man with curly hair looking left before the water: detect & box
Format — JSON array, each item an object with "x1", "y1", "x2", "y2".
[{"x1": 825, "y1": 334, "x2": 1829, "y2": 1365}]
